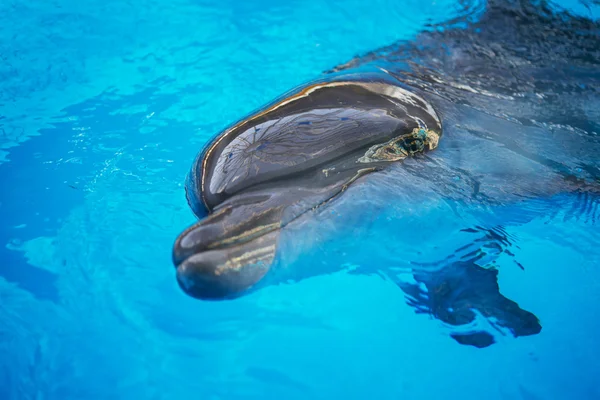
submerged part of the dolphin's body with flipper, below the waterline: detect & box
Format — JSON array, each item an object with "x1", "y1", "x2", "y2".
[{"x1": 175, "y1": 1, "x2": 600, "y2": 347}]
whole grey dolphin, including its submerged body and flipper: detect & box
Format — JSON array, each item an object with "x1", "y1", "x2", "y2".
[{"x1": 173, "y1": 1, "x2": 600, "y2": 348}]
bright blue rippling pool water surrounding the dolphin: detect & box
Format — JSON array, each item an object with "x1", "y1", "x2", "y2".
[{"x1": 0, "y1": 0, "x2": 600, "y2": 400}]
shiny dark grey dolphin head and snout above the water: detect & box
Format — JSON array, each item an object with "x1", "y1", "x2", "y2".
[{"x1": 173, "y1": 74, "x2": 441, "y2": 299}]
